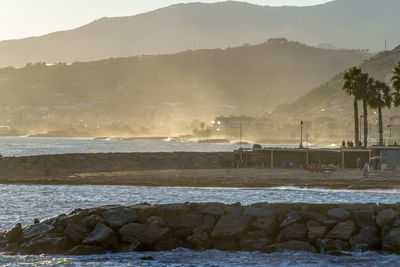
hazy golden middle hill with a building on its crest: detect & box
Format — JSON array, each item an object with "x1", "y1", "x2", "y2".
[{"x1": 0, "y1": 39, "x2": 368, "y2": 121}]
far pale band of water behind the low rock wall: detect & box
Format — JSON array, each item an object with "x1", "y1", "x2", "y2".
[{"x1": 0, "y1": 137, "x2": 300, "y2": 157}]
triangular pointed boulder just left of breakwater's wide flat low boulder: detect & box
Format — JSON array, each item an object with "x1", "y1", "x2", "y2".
[{"x1": 82, "y1": 224, "x2": 117, "y2": 248}]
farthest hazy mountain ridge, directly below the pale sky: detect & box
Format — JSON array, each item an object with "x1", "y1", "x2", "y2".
[{"x1": 0, "y1": 0, "x2": 400, "y2": 66}]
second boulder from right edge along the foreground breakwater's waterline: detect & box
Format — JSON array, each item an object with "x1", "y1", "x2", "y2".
[{"x1": 349, "y1": 226, "x2": 381, "y2": 251}]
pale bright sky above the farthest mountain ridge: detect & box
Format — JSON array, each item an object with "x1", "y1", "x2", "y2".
[{"x1": 0, "y1": 0, "x2": 331, "y2": 40}]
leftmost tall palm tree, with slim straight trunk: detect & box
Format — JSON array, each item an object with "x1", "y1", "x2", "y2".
[{"x1": 343, "y1": 67, "x2": 362, "y2": 147}]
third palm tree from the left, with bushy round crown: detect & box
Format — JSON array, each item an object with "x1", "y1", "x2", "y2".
[{"x1": 368, "y1": 81, "x2": 393, "y2": 146}]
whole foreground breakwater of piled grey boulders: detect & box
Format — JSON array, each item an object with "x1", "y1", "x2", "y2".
[{"x1": 0, "y1": 203, "x2": 400, "y2": 255}]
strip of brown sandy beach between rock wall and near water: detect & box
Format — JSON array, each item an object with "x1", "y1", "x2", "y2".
[{"x1": 0, "y1": 169, "x2": 400, "y2": 189}]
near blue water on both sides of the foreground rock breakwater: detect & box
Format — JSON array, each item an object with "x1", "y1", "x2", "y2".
[{"x1": 0, "y1": 185, "x2": 400, "y2": 267}]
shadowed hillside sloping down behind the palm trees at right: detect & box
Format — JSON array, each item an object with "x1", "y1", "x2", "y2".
[{"x1": 274, "y1": 46, "x2": 400, "y2": 118}]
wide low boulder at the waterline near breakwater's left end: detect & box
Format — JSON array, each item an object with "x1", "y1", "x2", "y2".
[{"x1": 19, "y1": 233, "x2": 68, "y2": 254}]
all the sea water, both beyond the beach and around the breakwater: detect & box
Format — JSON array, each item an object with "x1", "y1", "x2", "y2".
[{"x1": 0, "y1": 137, "x2": 400, "y2": 267}]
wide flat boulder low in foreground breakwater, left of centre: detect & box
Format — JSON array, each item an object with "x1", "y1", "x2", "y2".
[{"x1": 119, "y1": 223, "x2": 170, "y2": 246}]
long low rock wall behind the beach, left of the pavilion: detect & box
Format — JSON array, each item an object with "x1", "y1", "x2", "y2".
[{"x1": 0, "y1": 152, "x2": 233, "y2": 177}]
